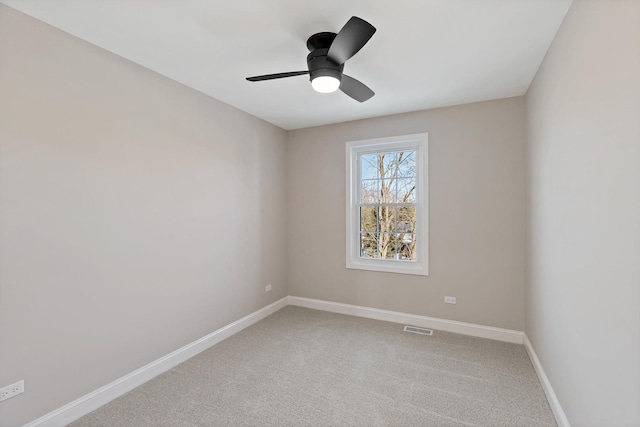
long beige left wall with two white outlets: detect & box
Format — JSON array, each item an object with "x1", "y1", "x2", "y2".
[{"x1": 0, "y1": 5, "x2": 287, "y2": 427}]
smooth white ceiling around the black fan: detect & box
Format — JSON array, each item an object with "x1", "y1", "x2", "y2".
[{"x1": 0, "y1": 0, "x2": 571, "y2": 129}]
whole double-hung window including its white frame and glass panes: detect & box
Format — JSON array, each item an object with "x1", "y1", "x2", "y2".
[{"x1": 346, "y1": 133, "x2": 429, "y2": 275}]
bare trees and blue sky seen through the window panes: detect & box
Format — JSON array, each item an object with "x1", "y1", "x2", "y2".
[{"x1": 358, "y1": 151, "x2": 418, "y2": 261}]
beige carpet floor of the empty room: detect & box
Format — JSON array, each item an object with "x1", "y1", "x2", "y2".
[{"x1": 71, "y1": 306, "x2": 556, "y2": 427}]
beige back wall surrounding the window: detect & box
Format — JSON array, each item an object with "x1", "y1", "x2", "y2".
[{"x1": 288, "y1": 97, "x2": 525, "y2": 330}]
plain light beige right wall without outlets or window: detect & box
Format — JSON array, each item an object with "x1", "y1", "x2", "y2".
[{"x1": 526, "y1": 0, "x2": 640, "y2": 427}]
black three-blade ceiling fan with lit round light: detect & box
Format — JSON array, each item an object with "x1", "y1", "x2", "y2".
[{"x1": 247, "y1": 16, "x2": 376, "y2": 102}]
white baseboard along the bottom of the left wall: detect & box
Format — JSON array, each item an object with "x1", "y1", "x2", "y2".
[{"x1": 24, "y1": 297, "x2": 288, "y2": 427}]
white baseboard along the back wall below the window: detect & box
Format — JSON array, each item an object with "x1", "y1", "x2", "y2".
[{"x1": 288, "y1": 296, "x2": 524, "y2": 344}]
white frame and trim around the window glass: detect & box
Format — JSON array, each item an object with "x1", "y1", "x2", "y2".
[{"x1": 346, "y1": 133, "x2": 429, "y2": 276}]
